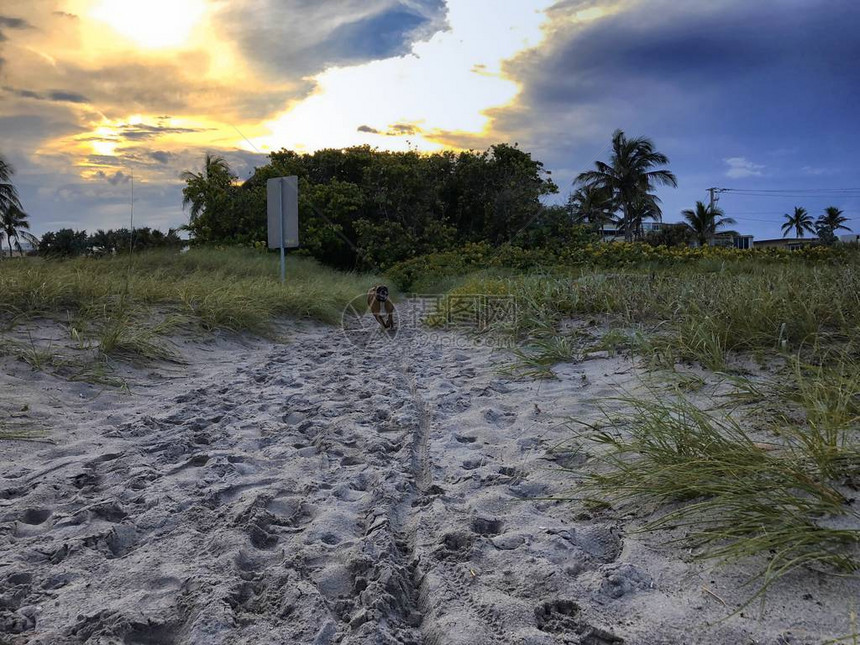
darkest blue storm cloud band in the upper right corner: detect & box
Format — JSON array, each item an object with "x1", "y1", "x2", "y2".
[{"x1": 530, "y1": 0, "x2": 860, "y2": 110}]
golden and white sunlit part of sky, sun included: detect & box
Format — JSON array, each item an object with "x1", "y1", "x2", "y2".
[{"x1": 5, "y1": 0, "x2": 592, "y2": 216}]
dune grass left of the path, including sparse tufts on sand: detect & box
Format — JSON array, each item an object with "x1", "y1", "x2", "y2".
[{"x1": 0, "y1": 248, "x2": 373, "y2": 368}]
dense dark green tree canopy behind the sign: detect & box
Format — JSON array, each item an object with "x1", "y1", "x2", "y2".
[{"x1": 179, "y1": 144, "x2": 560, "y2": 269}]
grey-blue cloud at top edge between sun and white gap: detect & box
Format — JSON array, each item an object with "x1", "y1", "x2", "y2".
[{"x1": 221, "y1": 0, "x2": 446, "y2": 79}]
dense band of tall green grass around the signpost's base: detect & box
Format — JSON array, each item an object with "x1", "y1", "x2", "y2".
[{"x1": 0, "y1": 249, "x2": 372, "y2": 331}]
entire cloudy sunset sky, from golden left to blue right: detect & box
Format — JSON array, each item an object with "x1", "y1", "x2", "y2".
[{"x1": 0, "y1": 0, "x2": 860, "y2": 239}]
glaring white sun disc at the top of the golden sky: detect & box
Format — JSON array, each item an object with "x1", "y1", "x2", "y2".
[{"x1": 89, "y1": 0, "x2": 206, "y2": 49}]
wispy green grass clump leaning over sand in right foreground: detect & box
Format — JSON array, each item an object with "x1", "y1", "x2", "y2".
[{"x1": 581, "y1": 398, "x2": 860, "y2": 591}]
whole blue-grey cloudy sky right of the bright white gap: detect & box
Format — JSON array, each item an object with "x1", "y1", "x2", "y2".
[{"x1": 470, "y1": 0, "x2": 860, "y2": 236}]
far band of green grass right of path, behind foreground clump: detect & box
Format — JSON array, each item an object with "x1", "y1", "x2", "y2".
[{"x1": 444, "y1": 261, "x2": 860, "y2": 369}]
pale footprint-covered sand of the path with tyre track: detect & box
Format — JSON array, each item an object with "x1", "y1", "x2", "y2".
[{"x1": 0, "y1": 308, "x2": 860, "y2": 645}]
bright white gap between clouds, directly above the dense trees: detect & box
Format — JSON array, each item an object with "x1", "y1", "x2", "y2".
[{"x1": 253, "y1": 0, "x2": 553, "y2": 151}]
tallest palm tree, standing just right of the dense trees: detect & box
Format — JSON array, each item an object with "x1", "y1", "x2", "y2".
[{"x1": 574, "y1": 130, "x2": 678, "y2": 241}]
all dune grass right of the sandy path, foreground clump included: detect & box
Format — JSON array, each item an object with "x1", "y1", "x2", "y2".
[{"x1": 428, "y1": 257, "x2": 860, "y2": 593}]
